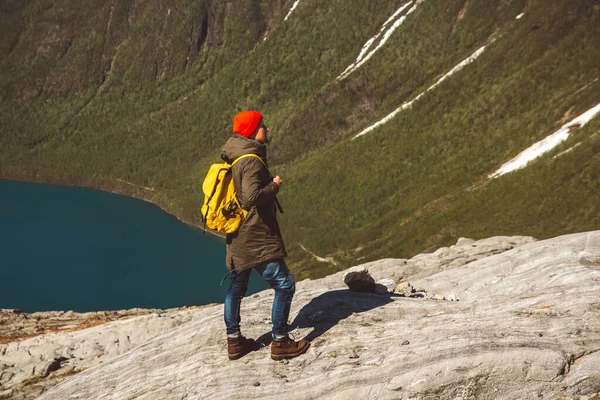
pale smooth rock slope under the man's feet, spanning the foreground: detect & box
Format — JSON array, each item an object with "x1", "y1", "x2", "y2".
[{"x1": 0, "y1": 231, "x2": 600, "y2": 400}]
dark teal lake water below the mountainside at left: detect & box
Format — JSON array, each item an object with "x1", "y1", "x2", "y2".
[{"x1": 0, "y1": 180, "x2": 268, "y2": 312}]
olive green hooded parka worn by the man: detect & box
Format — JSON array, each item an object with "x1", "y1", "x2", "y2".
[{"x1": 223, "y1": 134, "x2": 287, "y2": 271}]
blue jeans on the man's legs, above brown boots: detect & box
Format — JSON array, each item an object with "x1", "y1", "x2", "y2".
[{"x1": 224, "y1": 260, "x2": 296, "y2": 339}]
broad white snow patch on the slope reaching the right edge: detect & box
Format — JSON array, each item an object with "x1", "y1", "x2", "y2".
[{"x1": 488, "y1": 104, "x2": 600, "y2": 178}]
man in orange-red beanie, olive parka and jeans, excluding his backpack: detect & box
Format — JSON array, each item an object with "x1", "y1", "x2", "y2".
[{"x1": 222, "y1": 111, "x2": 310, "y2": 360}]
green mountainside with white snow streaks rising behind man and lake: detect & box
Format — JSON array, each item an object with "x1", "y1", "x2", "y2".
[{"x1": 0, "y1": 0, "x2": 600, "y2": 278}]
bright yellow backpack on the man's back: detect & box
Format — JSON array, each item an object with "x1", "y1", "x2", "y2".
[{"x1": 202, "y1": 154, "x2": 267, "y2": 233}]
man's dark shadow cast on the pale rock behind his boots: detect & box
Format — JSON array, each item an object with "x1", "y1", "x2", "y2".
[{"x1": 257, "y1": 289, "x2": 398, "y2": 346}]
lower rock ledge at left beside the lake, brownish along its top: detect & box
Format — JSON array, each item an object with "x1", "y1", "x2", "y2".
[{"x1": 0, "y1": 309, "x2": 202, "y2": 399}]
